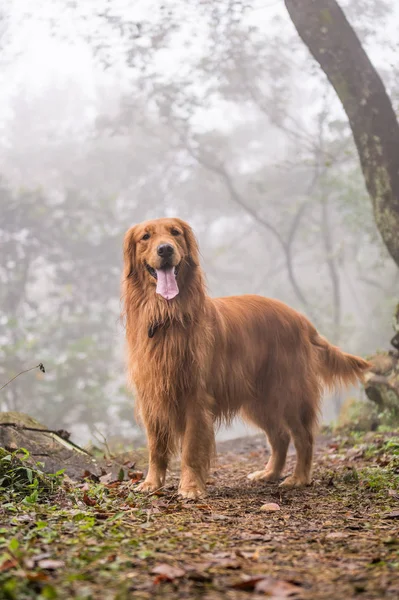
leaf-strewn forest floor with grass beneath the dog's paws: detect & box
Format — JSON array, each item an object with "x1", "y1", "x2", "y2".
[{"x1": 0, "y1": 432, "x2": 399, "y2": 600}]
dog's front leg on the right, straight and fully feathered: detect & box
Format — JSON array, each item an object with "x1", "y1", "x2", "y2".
[{"x1": 179, "y1": 402, "x2": 215, "y2": 499}]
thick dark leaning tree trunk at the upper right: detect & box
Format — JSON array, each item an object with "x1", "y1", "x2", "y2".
[{"x1": 285, "y1": 0, "x2": 399, "y2": 266}]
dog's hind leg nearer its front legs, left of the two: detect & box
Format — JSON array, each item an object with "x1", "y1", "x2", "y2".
[{"x1": 242, "y1": 402, "x2": 290, "y2": 481}]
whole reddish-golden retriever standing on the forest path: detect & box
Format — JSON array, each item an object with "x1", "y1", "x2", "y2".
[{"x1": 122, "y1": 218, "x2": 370, "y2": 499}]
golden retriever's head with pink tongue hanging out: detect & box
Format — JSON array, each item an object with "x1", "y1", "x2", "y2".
[{"x1": 124, "y1": 218, "x2": 199, "y2": 300}]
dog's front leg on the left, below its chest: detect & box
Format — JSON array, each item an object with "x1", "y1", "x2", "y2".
[{"x1": 137, "y1": 423, "x2": 170, "y2": 492}]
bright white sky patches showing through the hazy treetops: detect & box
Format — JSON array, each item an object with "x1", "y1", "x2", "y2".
[{"x1": 0, "y1": 0, "x2": 399, "y2": 132}]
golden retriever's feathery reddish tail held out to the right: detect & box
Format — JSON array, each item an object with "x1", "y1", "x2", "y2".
[{"x1": 311, "y1": 331, "x2": 371, "y2": 388}]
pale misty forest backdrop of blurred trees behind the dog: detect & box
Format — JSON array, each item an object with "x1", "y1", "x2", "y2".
[{"x1": 0, "y1": 0, "x2": 399, "y2": 443}]
